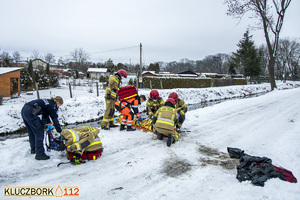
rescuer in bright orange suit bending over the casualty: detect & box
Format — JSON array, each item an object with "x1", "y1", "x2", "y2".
[{"x1": 115, "y1": 95, "x2": 146, "y2": 131}]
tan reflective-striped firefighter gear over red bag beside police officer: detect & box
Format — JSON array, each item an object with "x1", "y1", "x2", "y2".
[{"x1": 61, "y1": 126, "x2": 103, "y2": 165}]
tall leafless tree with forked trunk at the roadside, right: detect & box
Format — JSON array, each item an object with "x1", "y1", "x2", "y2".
[{"x1": 225, "y1": 0, "x2": 291, "y2": 90}]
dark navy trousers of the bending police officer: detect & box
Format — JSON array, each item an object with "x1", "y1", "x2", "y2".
[{"x1": 21, "y1": 106, "x2": 45, "y2": 157}]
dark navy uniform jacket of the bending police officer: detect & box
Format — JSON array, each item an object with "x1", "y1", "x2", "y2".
[{"x1": 26, "y1": 99, "x2": 62, "y2": 133}]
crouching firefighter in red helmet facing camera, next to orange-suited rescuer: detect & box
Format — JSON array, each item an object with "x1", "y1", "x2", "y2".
[{"x1": 146, "y1": 90, "x2": 165, "y2": 119}]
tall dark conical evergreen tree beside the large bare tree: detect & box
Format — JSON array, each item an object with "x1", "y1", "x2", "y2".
[{"x1": 231, "y1": 30, "x2": 261, "y2": 79}]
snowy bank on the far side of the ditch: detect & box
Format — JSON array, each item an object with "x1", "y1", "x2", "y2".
[{"x1": 0, "y1": 80, "x2": 300, "y2": 135}]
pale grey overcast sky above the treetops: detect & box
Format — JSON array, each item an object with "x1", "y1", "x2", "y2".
[{"x1": 0, "y1": 0, "x2": 300, "y2": 64}]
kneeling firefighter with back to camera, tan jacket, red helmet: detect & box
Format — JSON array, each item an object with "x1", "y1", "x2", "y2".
[{"x1": 152, "y1": 98, "x2": 178, "y2": 147}]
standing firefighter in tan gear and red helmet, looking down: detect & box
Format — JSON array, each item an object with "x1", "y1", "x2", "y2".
[{"x1": 101, "y1": 69, "x2": 127, "y2": 130}]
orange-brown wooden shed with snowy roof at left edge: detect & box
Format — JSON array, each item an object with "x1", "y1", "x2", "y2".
[{"x1": 0, "y1": 67, "x2": 22, "y2": 97}]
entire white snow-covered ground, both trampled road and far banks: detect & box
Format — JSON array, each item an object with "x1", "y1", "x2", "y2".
[{"x1": 0, "y1": 82, "x2": 300, "y2": 200}]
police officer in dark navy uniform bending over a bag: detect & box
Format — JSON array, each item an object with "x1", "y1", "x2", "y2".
[{"x1": 21, "y1": 96, "x2": 63, "y2": 160}]
